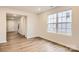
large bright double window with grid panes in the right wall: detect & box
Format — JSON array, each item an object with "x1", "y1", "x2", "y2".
[{"x1": 48, "y1": 10, "x2": 72, "y2": 33}]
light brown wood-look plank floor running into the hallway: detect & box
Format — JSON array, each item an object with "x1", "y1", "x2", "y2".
[{"x1": 0, "y1": 32, "x2": 70, "y2": 52}]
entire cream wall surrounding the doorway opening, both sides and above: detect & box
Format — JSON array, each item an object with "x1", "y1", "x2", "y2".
[{"x1": 0, "y1": 7, "x2": 38, "y2": 43}]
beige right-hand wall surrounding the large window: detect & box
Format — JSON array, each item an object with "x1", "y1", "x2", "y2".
[{"x1": 39, "y1": 7, "x2": 79, "y2": 50}]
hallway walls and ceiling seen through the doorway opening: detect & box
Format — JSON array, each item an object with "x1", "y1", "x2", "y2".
[{"x1": 6, "y1": 13, "x2": 27, "y2": 41}]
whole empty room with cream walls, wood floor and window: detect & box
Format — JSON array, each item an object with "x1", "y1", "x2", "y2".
[{"x1": 0, "y1": 6, "x2": 79, "y2": 52}]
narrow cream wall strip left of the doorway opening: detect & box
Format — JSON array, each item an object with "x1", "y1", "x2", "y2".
[{"x1": 0, "y1": 8, "x2": 6, "y2": 43}]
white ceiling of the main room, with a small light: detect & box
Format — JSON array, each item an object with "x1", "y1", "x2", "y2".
[{"x1": 6, "y1": 6, "x2": 54, "y2": 14}]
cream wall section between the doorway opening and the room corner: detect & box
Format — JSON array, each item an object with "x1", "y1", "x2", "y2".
[{"x1": 27, "y1": 15, "x2": 40, "y2": 38}]
